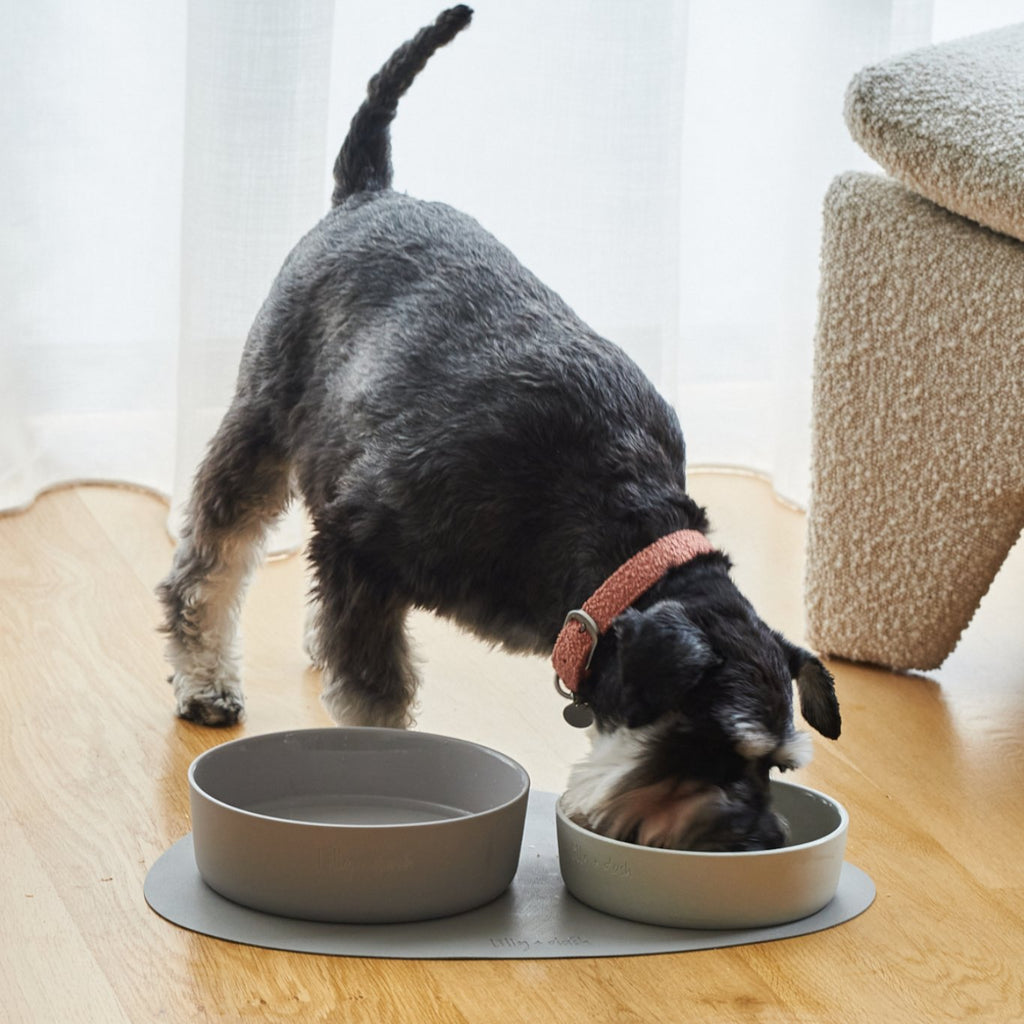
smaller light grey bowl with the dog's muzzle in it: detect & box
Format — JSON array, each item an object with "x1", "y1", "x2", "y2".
[{"x1": 556, "y1": 779, "x2": 850, "y2": 929}]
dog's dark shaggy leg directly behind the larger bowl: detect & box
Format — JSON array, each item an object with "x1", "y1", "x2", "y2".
[{"x1": 306, "y1": 534, "x2": 419, "y2": 729}]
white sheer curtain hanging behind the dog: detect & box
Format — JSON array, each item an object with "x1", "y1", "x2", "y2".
[{"x1": 0, "y1": 0, "x2": 1024, "y2": 543}]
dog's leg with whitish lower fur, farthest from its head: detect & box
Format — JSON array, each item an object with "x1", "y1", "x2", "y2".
[{"x1": 157, "y1": 400, "x2": 291, "y2": 725}]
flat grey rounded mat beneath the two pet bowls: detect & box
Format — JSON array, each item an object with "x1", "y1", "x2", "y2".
[{"x1": 144, "y1": 793, "x2": 874, "y2": 959}]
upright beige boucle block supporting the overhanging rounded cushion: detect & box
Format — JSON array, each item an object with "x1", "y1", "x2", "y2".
[{"x1": 806, "y1": 173, "x2": 1024, "y2": 670}]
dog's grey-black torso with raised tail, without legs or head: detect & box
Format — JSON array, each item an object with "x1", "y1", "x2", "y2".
[{"x1": 253, "y1": 7, "x2": 703, "y2": 638}]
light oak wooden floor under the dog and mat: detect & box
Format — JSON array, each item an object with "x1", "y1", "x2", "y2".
[{"x1": 0, "y1": 473, "x2": 1024, "y2": 1024}]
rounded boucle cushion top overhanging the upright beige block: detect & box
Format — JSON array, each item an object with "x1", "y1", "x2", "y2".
[{"x1": 845, "y1": 25, "x2": 1024, "y2": 240}]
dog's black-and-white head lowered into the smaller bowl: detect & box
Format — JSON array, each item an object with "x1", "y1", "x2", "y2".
[{"x1": 564, "y1": 574, "x2": 840, "y2": 851}]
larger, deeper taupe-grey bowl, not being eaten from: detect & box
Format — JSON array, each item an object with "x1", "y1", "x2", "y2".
[{"x1": 188, "y1": 728, "x2": 529, "y2": 924}]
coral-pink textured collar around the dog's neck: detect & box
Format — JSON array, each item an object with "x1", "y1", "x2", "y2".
[{"x1": 551, "y1": 529, "x2": 715, "y2": 697}]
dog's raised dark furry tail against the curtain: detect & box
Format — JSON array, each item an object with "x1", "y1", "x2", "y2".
[{"x1": 332, "y1": 4, "x2": 473, "y2": 206}]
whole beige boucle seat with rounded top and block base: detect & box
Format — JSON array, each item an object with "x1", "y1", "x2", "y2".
[{"x1": 806, "y1": 26, "x2": 1024, "y2": 669}]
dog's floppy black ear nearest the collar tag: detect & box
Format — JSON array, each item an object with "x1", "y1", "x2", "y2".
[{"x1": 612, "y1": 600, "x2": 718, "y2": 728}]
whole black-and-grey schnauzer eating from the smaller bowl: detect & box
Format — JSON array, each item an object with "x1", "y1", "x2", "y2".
[{"x1": 158, "y1": 6, "x2": 841, "y2": 850}]
